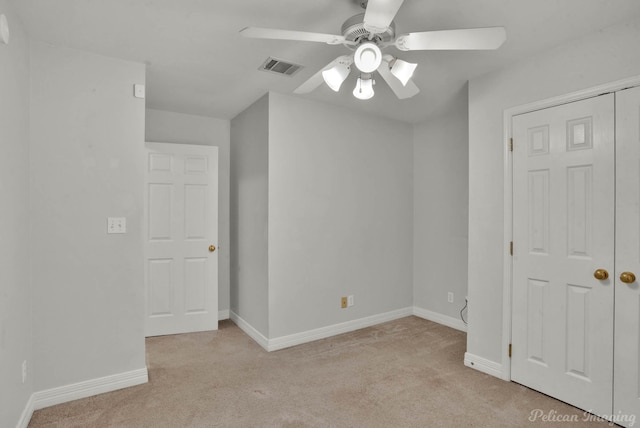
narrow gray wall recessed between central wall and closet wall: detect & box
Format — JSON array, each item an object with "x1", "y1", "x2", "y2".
[{"x1": 413, "y1": 85, "x2": 469, "y2": 319}]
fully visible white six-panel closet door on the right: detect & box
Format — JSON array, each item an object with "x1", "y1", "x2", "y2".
[{"x1": 511, "y1": 94, "x2": 616, "y2": 415}]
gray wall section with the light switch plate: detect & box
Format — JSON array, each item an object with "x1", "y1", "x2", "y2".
[{"x1": 30, "y1": 43, "x2": 145, "y2": 391}]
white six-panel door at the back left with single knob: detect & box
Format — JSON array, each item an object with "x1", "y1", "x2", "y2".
[{"x1": 145, "y1": 143, "x2": 218, "y2": 336}]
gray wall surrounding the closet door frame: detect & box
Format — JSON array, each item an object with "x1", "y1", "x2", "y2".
[{"x1": 467, "y1": 15, "x2": 640, "y2": 364}]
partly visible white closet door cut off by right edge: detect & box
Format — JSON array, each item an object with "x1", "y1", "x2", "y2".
[{"x1": 613, "y1": 88, "x2": 640, "y2": 426}]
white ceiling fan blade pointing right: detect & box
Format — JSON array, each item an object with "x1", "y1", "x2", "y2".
[{"x1": 396, "y1": 27, "x2": 507, "y2": 51}]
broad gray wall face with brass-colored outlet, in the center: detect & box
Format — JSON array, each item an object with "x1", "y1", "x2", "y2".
[{"x1": 269, "y1": 93, "x2": 413, "y2": 338}]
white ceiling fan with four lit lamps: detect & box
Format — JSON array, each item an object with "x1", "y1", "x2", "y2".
[{"x1": 240, "y1": 0, "x2": 506, "y2": 100}]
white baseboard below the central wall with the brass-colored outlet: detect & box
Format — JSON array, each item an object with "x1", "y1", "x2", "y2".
[{"x1": 267, "y1": 308, "x2": 412, "y2": 351}]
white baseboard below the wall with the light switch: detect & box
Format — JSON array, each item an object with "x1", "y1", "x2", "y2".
[{"x1": 32, "y1": 367, "x2": 149, "y2": 410}]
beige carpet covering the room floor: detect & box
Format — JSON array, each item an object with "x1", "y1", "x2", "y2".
[{"x1": 29, "y1": 317, "x2": 608, "y2": 428}]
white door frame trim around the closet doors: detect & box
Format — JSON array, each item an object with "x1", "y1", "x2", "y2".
[{"x1": 500, "y1": 76, "x2": 640, "y2": 381}]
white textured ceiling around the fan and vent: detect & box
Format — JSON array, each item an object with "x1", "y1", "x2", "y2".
[{"x1": 14, "y1": 0, "x2": 640, "y2": 122}]
